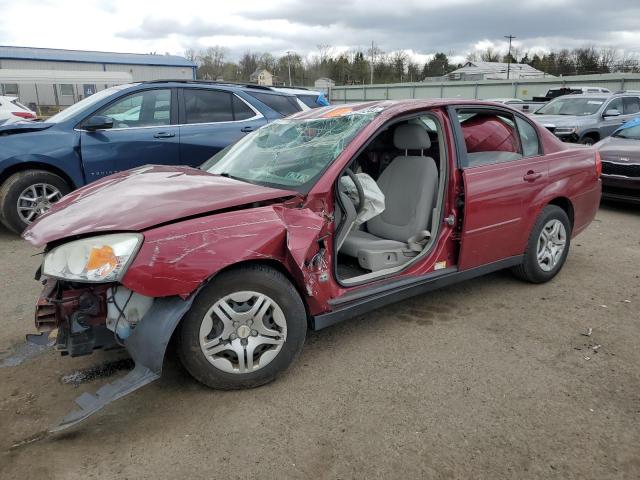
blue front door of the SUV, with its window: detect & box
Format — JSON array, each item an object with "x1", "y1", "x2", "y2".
[{"x1": 79, "y1": 88, "x2": 180, "y2": 182}]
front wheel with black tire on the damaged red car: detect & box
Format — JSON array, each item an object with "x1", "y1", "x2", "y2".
[{"x1": 178, "y1": 265, "x2": 307, "y2": 390}]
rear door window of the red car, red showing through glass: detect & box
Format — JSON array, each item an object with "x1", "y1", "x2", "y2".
[{"x1": 458, "y1": 110, "x2": 522, "y2": 167}]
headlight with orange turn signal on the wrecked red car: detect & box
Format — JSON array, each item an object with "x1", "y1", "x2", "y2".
[{"x1": 42, "y1": 233, "x2": 143, "y2": 282}]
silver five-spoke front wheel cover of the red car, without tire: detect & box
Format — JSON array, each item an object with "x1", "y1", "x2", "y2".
[{"x1": 200, "y1": 291, "x2": 287, "y2": 373}]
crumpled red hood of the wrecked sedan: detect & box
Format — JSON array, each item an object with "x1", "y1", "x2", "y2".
[{"x1": 23, "y1": 165, "x2": 298, "y2": 246}]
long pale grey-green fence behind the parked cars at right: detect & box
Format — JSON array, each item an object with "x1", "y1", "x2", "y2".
[{"x1": 330, "y1": 73, "x2": 640, "y2": 103}]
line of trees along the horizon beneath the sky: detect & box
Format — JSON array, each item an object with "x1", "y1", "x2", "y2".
[{"x1": 185, "y1": 44, "x2": 640, "y2": 86}]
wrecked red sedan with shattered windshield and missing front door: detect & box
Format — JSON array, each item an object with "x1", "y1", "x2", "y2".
[{"x1": 24, "y1": 100, "x2": 601, "y2": 428}]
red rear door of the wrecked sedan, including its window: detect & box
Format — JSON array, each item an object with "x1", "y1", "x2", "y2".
[{"x1": 452, "y1": 107, "x2": 548, "y2": 270}]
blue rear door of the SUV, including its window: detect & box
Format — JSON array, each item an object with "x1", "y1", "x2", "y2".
[{"x1": 179, "y1": 88, "x2": 267, "y2": 167}]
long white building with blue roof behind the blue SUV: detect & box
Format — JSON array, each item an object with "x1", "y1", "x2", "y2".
[{"x1": 0, "y1": 46, "x2": 196, "y2": 107}]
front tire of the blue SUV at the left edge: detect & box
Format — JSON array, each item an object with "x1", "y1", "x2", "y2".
[{"x1": 0, "y1": 170, "x2": 71, "y2": 234}]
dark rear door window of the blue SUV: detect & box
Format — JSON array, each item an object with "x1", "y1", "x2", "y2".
[{"x1": 184, "y1": 88, "x2": 233, "y2": 123}]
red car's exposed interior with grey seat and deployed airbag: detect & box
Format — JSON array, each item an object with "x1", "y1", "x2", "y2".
[{"x1": 335, "y1": 115, "x2": 446, "y2": 285}]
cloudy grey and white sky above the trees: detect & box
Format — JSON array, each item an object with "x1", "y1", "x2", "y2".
[{"x1": 0, "y1": 0, "x2": 640, "y2": 62}]
